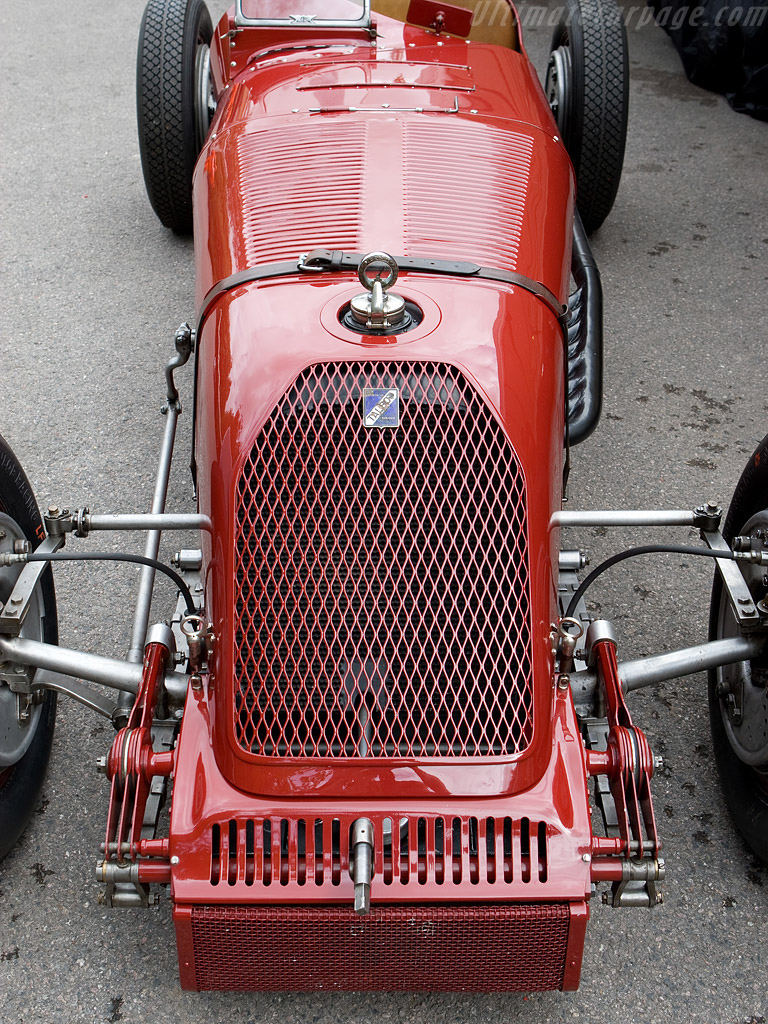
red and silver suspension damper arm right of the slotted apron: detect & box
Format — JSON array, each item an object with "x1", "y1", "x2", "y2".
[{"x1": 586, "y1": 620, "x2": 665, "y2": 906}]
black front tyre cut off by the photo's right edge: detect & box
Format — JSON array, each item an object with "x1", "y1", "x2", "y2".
[{"x1": 709, "y1": 436, "x2": 768, "y2": 864}]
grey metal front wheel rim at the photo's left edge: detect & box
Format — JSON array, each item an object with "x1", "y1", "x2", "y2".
[{"x1": 0, "y1": 513, "x2": 43, "y2": 770}]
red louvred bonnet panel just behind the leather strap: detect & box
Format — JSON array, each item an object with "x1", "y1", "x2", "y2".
[{"x1": 196, "y1": 102, "x2": 570, "y2": 303}]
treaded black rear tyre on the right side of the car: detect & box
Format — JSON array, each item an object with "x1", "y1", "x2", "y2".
[{"x1": 545, "y1": 0, "x2": 630, "y2": 234}]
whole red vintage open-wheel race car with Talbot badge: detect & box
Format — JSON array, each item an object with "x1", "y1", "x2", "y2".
[{"x1": 0, "y1": 0, "x2": 768, "y2": 990}]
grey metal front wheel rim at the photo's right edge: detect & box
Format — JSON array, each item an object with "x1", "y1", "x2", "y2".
[{"x1": 717, "y1": 511, "x2": 768, "y2": 770}]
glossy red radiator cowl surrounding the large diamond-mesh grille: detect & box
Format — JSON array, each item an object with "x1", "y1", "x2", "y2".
[{"x1": 198, "y1": 275, "x2": 562, "y2": 797}]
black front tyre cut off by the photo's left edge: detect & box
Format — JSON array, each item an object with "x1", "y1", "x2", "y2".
[{"x1": 0, "y1": 437, "x2": 58, "y2": 860}]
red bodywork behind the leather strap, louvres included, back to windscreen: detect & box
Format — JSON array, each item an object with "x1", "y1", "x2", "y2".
[{"x1": 195, "y1": 32, "x2": 573, "y2": 303}]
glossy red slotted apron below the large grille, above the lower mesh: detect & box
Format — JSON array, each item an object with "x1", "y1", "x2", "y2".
[{"x1": 170, "y1": 679, "x2": 591, "y2": 903}]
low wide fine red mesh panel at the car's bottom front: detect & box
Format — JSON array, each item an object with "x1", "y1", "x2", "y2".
[{"x1": 193, "y1": 903, "x2": 570, "y2": 992}]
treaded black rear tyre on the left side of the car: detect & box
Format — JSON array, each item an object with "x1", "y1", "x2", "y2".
[{"x1": 136, "y1": 0, "x2": 213, "y2": 234}]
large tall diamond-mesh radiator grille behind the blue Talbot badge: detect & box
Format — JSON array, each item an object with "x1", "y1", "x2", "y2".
[{"x1": 234, "y1": 361, "x2": 532, "y2": 758}]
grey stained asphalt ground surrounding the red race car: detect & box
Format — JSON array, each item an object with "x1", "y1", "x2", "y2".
[{"x1": 0, "y1": 0, "x2": 768, "y2": 1024}]
